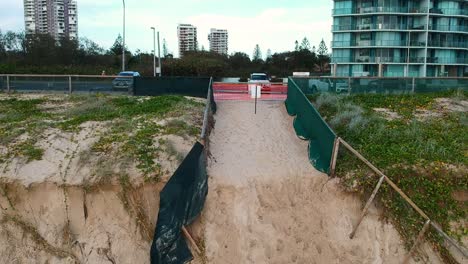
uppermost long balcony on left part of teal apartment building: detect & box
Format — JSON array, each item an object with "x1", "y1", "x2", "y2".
[{"x1": 332, "y1": 6, "x2": 427, "y2": 16}]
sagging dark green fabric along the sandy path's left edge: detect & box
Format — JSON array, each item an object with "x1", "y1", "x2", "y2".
[{"x1": 151, "y1": 142, "x2": 208, "y2": 264}]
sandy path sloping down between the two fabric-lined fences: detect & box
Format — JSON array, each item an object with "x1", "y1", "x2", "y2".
[{"x1": 203, "y1": 102, "x2": 438, "y2": 264}]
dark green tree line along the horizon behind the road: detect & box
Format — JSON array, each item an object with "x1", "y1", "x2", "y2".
[{"x1": 0, "y1": 29, "x2": 330, "y2": 78}]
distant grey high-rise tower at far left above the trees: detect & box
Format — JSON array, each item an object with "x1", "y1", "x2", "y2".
[{"x1": 24, "y1": 0, "x2": 78, "y2": 40}]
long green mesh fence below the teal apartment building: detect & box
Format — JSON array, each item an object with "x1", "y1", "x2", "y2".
[{"x1": 293, "y1": 77, "x2": 468, "y2": 94}]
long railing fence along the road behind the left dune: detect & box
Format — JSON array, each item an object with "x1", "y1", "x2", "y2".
[{"x1": 0, "y1": 74, "x2": 134, "y2": 94}]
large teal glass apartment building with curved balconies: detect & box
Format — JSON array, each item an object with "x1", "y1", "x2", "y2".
[{"x1": 331, "y1": 0, "x2": 468, "y2": 77}]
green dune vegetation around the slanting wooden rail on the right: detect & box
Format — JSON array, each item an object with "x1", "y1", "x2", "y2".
[{"x1": 310, "y1": 92, "x2": 468, "y2": 262}]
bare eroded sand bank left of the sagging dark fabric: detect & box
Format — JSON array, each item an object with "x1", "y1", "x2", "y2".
[{"x1": 0, "y1": 118, "x2": 195, "y2": 264}]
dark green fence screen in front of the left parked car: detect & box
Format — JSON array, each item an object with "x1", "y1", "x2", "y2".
[{"x1": 133, "y1": 77, "x2": 210, "y2": 98}]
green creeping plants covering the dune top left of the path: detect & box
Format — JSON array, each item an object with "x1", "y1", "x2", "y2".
[{"x1": 0, "y1": 94, "x2": 204, "y2": 181}]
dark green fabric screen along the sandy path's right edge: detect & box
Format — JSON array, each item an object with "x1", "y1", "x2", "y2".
[{"x1": 286, "y1": 78, "x2": 336, "y2": 173}]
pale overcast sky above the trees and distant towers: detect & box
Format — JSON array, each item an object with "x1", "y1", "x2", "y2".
[{"x1": 0, "y1": 0, "x2": 333, "y2": 56}]
